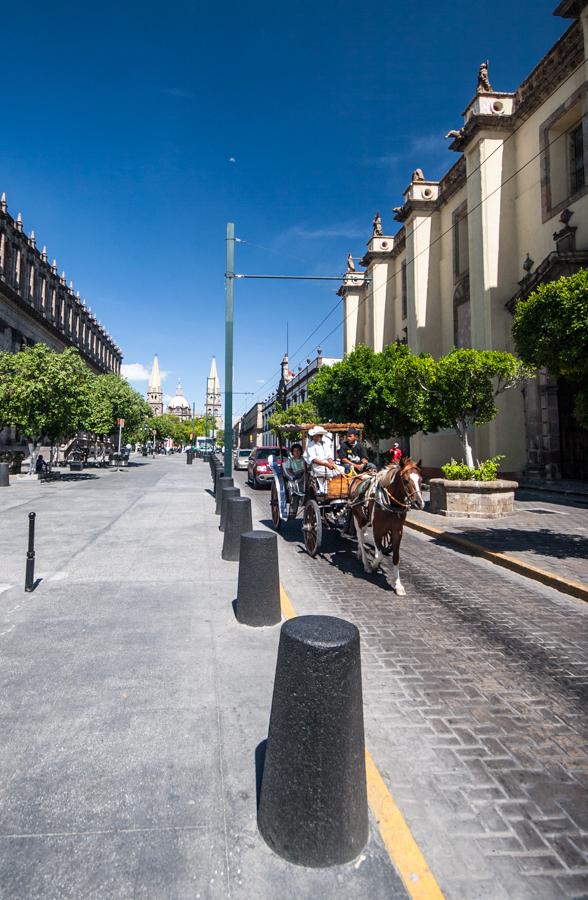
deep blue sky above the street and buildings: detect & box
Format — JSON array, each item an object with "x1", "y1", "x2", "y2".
[{"x1": 0, "y1": 0, "x2": 569, "y2": 420}]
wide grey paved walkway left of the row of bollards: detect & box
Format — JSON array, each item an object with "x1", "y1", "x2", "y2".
[{"x1": 0, "y1": 457, "x2": 405, "y2": 900}]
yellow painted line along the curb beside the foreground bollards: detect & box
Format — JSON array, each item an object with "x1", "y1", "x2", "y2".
[{"x1": 280, "y1": 584, "x2": 443, "y2": 900}]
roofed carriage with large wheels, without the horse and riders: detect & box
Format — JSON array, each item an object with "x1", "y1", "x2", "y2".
[{"x1": 270, "y1": 422, "x2": 363, "y2": 556}]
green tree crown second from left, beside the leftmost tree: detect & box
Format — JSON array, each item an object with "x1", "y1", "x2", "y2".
[{"x1": 84, "y1": 374, "x2": 152, "y2": 441}]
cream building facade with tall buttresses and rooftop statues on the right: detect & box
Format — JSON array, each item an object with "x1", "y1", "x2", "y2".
[{"x1": 339, "y1": 0, "x2": 588, "y2": 478}]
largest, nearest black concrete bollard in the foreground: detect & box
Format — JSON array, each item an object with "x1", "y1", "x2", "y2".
[{"x1": 257, "y1": 616, "x2": 368, "y2": 868}]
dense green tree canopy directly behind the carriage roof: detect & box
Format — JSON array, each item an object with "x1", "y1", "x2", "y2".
[{"x1": 308, "y1": 343, "x2": 430, "y2": 440}]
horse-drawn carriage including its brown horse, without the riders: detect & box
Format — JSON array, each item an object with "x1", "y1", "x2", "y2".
[{"x1": 268, "y1": 422, "x2": 424, "y2": 594}]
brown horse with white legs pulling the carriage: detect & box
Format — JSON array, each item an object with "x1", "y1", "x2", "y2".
[{"x1": 348, "y1": 458, "x2": 425, "y2": 596}]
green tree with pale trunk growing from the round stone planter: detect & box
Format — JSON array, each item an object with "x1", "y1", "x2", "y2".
[{"x1": 417, "y1": 349, "x2": 529, "y2": 469}]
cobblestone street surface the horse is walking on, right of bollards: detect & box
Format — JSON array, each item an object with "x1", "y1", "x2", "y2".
[{"x1": 237, "y1": 468, "x2": 588, "y2": 898}]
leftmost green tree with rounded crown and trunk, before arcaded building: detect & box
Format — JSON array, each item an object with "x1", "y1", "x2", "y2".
[{"x1": 0, "y1": 344, "x2": 93, "y2": 471}]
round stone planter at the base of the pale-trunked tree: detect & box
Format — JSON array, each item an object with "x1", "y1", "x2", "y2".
[{"x1": 429, "y1": 478, "x2": 519, "y2": 519}]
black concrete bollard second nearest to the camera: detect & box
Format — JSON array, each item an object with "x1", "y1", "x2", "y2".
[{"x1": 236, "y1": 531, "x2": 282, "y2": 627}]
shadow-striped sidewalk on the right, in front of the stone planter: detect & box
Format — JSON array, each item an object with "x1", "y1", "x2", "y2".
[{"x1": 408, "y1": 489, "x2": 588, "y2": 588}]
